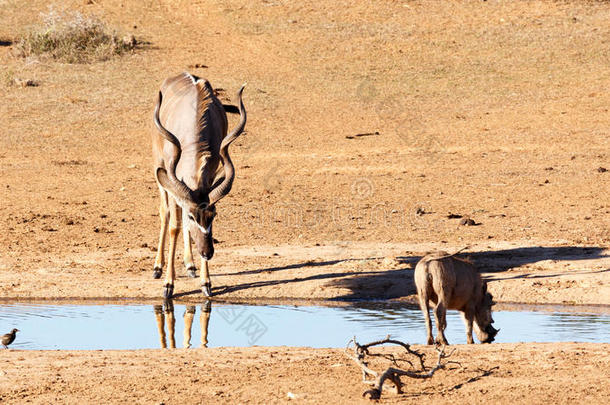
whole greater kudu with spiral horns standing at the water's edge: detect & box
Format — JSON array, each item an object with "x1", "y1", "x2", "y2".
[{"x1": 153, "y1": 73, "x2": 246, "y2": 298}]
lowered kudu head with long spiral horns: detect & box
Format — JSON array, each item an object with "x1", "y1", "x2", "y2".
[{"x1": 154, "y1": 84, "x2": 246, "y2": 259}]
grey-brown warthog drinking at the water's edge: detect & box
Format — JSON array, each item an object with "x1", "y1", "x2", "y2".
[{"x1": 415, "y1": 252, "x2": 499, "y2": 345}]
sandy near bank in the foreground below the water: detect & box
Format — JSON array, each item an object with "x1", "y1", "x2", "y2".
[{"x1": 0, "y1": 343, "x2": 610, "y2": 404}]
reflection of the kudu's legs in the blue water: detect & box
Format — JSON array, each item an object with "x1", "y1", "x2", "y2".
[{"x1": 154, "y1": 300, "x2": 212, "y2": 349}]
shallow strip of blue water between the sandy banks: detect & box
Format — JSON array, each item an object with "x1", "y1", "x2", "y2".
[{"x1": 0, "y1": 303, "x2": 610, "y2": 350}]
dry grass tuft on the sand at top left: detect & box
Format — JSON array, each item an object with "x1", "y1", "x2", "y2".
[{"x1": 16, "y1": 7, "x2": 136, "y2": 63}]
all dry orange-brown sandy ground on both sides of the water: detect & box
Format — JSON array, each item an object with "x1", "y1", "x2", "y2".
[{"x1": 0, "y1": 0, "x2": 610, "y2": 403}]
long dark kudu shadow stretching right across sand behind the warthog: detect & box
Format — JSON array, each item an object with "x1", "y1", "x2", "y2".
[{"x1": 170, "y1": 246, "x2": 610, "y2": 301}]
